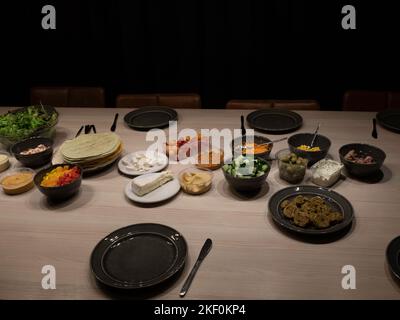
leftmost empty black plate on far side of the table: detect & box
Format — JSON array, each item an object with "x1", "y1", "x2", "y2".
[{"x1": 124, "y1": 107, "x2": 178, "y2": 130}]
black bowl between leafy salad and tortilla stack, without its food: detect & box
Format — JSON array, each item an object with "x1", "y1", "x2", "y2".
[{"x1": 11, "y1": 137, "x2": 53, "y2": 168}]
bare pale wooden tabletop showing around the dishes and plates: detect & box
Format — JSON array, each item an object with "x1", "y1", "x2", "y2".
[{"x1": 0, "y1": 108, "x2": 400, "y2": 299}]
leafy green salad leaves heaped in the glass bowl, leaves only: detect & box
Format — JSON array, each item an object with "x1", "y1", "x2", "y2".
[{"x1": 0, "y1": 106, "x2": 58, "y2": 140}]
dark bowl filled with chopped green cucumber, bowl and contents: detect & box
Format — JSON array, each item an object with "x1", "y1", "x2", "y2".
[{"x1": 222, "y1": 155, "x2": 271, "y2": 192}]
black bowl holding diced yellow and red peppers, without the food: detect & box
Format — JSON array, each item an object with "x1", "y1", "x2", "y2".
[{"x1": 33, "y1": 164, "x2": 82, "y2": 201}]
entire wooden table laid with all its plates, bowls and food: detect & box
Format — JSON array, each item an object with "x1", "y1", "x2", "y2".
[{"x1": 0, "y1": 106, "x2": 400, "y2": 299}]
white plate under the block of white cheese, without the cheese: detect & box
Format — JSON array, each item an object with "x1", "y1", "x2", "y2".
[{"x1": 125, "y1": 173, "x2": 181, "y2": 203}]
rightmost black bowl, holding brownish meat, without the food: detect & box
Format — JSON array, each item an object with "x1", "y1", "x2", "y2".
[{"x1": 339, "y1": 143, "x2": 386, "y2": 178}]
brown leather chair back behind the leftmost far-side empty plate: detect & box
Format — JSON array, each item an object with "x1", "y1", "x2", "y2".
[{"x1": 116, "y1": 93, "x2": 201, "y2": 109}]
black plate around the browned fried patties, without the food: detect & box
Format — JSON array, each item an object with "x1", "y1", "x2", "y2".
[{"x1": 268, "y1": 186, "x2": 354, "y2": 235}]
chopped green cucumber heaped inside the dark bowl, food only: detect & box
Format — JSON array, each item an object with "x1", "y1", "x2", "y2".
[{"x1": 222, "y1": 155, "x2": 269, "y2": 178}]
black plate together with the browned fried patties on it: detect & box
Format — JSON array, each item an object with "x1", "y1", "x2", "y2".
[{"x1": 268, "y1": 186, "x2": 354, "y2": 235}]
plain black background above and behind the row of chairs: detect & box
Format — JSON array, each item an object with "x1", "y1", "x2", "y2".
[{"x1": 0, "y1": 0, "x2": 400, "y2": 109}]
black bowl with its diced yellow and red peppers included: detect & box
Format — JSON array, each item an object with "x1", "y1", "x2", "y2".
[{"x1": 34, "y1": 164, "x2": 82, "y2": 200}]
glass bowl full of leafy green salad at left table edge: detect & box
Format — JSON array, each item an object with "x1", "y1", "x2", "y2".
[{"x1": 0, "y1": 105, "x2": 58, "y2": 148}]
